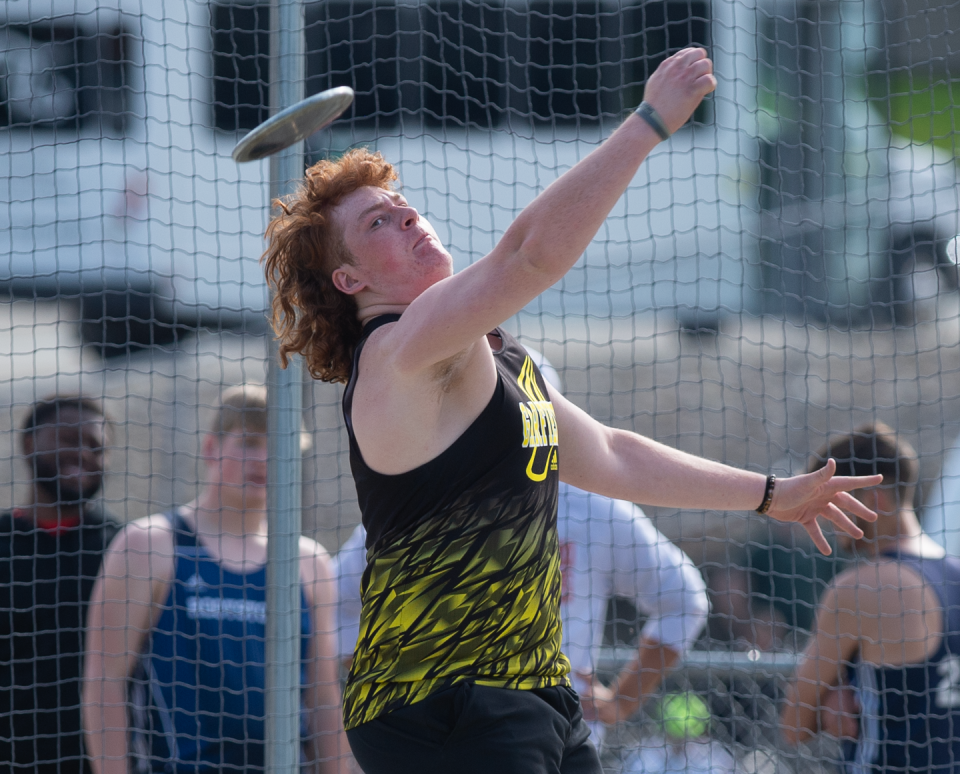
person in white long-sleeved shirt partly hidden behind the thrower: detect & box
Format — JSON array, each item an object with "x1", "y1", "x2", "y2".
[{"x1": 333, "y1": 349, "x2": 709, "y2": 744}]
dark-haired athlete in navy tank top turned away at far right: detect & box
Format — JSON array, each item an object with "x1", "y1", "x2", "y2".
[{"x1": 782, "y1": 424, "x2": 960, "y2": 774}]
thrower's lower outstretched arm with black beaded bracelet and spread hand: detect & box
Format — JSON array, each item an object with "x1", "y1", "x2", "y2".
[{"x1": 550, "y1": 390, "x2": 883, "y2": 554}]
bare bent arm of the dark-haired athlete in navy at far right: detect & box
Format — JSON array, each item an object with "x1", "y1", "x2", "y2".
[{"x1": 780, "y1": 571, "x2": 860, "y2": 744}]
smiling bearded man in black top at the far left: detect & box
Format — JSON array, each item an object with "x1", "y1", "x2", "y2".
[{"x1": 0, "y1": 396, "x2": 117, "y2": 774}]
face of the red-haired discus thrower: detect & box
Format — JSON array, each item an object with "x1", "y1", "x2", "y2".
[{"x1": 333, "y1": 187, "x2": 453, "y2": 305}]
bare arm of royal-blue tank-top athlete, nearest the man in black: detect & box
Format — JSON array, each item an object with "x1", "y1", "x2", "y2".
[{"x1": 83, "y1": 517, "x2": 173, "y2": 774}]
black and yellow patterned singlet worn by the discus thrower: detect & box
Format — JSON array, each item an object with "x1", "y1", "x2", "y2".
[{"x1": 343, "y1": 315, "x2": 570, "y2": 730}]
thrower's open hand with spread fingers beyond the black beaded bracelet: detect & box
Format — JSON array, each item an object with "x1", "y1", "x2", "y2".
[{"x1": 767, "y1": 460, "x2": 883, "y2": 555}]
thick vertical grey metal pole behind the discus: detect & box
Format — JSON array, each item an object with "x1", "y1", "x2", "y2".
[{"x1": 265, "y1": 0, "x2": 304, "y2": 774}]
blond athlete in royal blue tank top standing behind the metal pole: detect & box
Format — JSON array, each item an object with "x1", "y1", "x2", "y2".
[{"x1": 84, "y1": 386, "x2": 349, "y2": 774}]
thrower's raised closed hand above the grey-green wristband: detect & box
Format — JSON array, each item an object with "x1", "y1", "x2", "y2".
[{"x1": 643, "y1": 48, "x2": 717, "y2": 133}]
